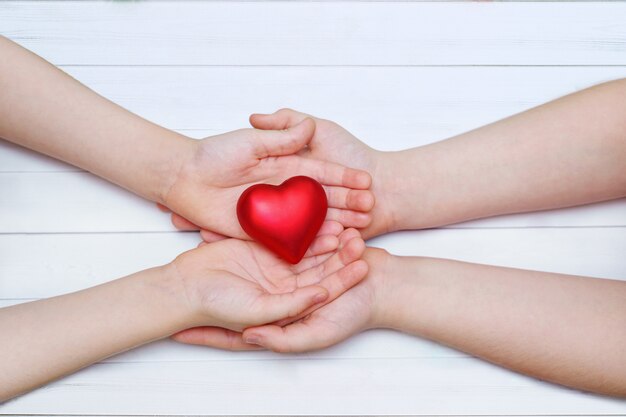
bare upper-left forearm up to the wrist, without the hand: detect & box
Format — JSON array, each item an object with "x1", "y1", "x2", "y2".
[{"x1": 0, "y1": 37, "x2": 191, "y2": 202}]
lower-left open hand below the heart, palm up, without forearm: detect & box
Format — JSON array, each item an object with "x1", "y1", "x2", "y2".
[{"x1": 168, "y1": 229, "x2": 367, "y2": 349}]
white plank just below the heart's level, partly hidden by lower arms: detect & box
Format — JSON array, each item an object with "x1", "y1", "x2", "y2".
[{"x1": 0, "y1": 228, "x2": 626, "y2": 362}]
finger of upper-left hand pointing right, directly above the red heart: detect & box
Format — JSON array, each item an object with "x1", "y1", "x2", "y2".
[{"x1": 298, "y1": 156, "x2": 372, "y2": 190}]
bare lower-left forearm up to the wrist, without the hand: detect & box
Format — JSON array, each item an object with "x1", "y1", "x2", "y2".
[{"x1": 0, "y1": 266, "x2": 187, "y2": 402}]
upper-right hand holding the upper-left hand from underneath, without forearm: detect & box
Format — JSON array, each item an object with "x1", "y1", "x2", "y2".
[{"x1": 250, "y1": 109, "x2": 395, "y2": 239}]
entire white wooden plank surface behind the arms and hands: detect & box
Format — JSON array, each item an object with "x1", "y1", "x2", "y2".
[{"x1": 0, "y1": 1, "x2": 626, "y2": 415}]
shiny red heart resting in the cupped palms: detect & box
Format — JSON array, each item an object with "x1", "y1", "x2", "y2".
[{"x1": 237, "y1": 176, "x2": 328, "y2": 264}]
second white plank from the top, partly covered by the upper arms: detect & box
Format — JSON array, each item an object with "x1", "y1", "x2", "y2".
[{"x1": 0, "y1": 67, "x2": 626, "y2": 172}]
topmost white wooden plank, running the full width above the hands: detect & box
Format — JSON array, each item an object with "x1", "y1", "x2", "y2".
[{"x1": 0, "y1": 1, "x2": 626, "y2": 65}]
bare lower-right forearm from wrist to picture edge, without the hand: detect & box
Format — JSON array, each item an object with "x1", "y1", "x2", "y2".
[{"x1": 381, "y1": 257, "x2": 626, "y2": 396}]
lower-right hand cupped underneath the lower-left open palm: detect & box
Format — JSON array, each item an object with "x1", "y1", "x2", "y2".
[{"x1": 175, "y1": 240, "x2": 390, "y2": 352}]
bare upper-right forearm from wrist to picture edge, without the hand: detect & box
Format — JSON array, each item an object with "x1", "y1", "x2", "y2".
[{"x1": 381, "y1": 76, "x2": 626, "y2": 229}]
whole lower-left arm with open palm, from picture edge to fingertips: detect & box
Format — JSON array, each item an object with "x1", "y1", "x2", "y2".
[{"x1": 0, "y1": 229, "x2": 367, "y2": 402}]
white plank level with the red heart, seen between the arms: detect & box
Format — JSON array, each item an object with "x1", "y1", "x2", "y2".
[{"x1": 0, "y1": 172, "x2": 626, "y2": 233}]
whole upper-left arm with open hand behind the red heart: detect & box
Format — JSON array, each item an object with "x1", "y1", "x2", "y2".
[{"x1": 0, "y1": 36, "x2": 373, "y2": 238}]
